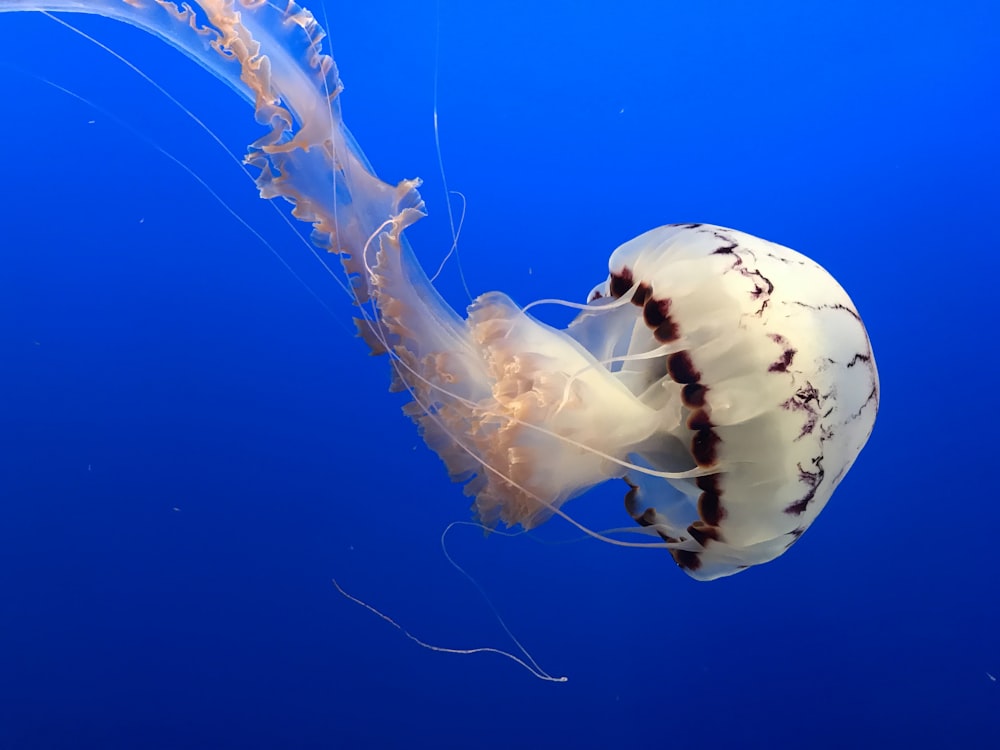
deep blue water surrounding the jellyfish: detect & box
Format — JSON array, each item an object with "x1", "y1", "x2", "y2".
[{"x1": 0, "y1": 0, "x2": 1000, "y2": 750}]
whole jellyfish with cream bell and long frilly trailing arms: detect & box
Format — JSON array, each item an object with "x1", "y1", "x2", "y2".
[{"x1": 0, "y1": 0, "x2": 879, "y2": 580}]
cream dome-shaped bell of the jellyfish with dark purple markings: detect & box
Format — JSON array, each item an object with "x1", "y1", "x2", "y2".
[{"x1": 588, "y1": 224, "x2": 879, "y2": 579}]
